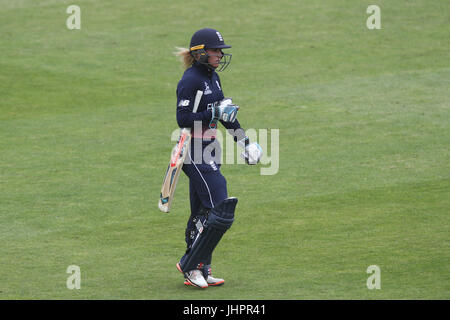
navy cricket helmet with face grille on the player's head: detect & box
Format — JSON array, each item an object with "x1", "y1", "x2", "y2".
[{"x1": 189, "y1": 28, "x2": 231, "y2": 71}]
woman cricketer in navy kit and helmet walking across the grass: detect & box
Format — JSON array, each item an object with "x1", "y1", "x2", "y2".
[{"x1": 176, "y1": 28, "x2": 262, "y2": 288}]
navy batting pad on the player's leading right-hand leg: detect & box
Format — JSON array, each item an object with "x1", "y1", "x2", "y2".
[{"x1": 180, "y1": 197, "x2": 238, "y2": 272}]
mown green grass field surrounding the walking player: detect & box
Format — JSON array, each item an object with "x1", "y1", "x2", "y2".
[{"x1": 0, "y1": 0, "x2": 450, "y2": 300}]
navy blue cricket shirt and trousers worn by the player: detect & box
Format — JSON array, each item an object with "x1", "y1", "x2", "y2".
[{"x1": 177, "y1": 62, "x2": 245, "y2": 264}]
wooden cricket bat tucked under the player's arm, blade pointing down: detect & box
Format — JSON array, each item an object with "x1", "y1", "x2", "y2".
[{"x1": 158, "y1": 90, "x2": 203, "y2": 212}]
